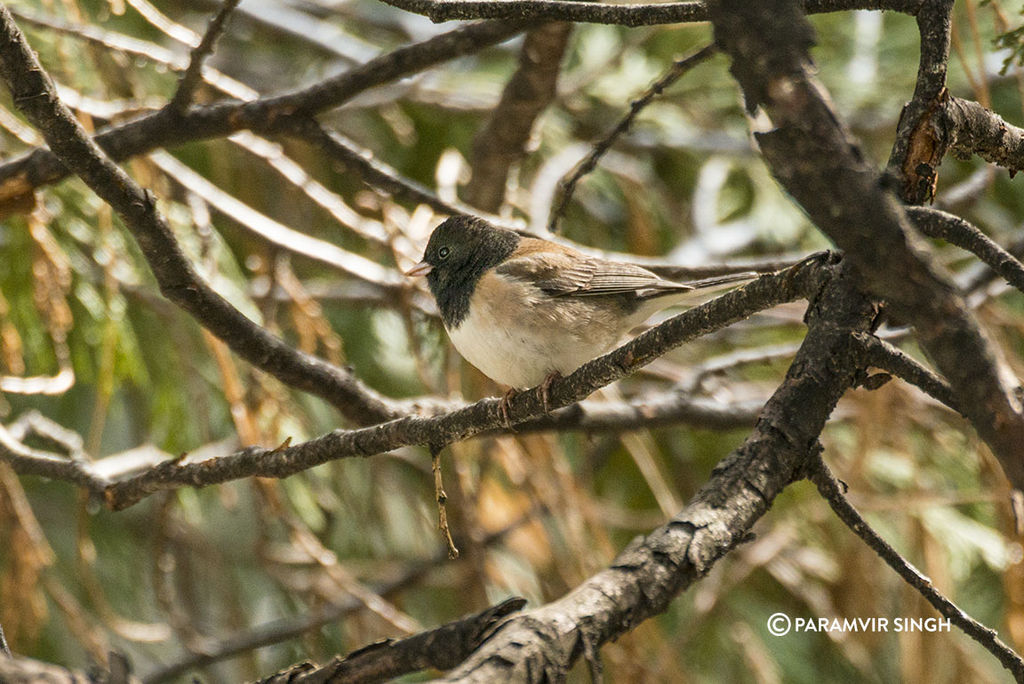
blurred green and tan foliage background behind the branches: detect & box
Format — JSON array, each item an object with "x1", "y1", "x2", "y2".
[{"x1": 0, "y1": 0, "x2": 1024, "y2": 683}]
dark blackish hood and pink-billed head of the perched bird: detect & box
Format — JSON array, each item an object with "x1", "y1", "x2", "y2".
[{"x1": 411, "y1": 216, "x2": 520, "y2": 329}]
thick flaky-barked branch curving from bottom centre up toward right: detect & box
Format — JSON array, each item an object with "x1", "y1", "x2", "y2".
[{"x1": 444, "y1": 262, "x2": 873, "y2": 682}]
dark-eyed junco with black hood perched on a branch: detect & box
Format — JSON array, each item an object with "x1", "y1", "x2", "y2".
[{"x1": 407, "y1": 216, "x2": 757, "y2": 401}]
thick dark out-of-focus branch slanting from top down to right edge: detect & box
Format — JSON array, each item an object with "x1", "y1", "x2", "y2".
[{"x1": 712, "y1": 0, "x2": 1024, "y2": 488}]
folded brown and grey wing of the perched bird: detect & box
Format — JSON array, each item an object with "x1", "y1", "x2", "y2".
[{"x1": 498, "y1": 240, "x2": 692, "y2": 298}]
